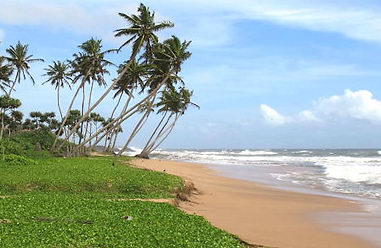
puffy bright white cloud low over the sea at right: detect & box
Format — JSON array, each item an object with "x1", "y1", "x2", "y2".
[{"x1": 260, "y1": 90, "x2": 381, "y2": 126}]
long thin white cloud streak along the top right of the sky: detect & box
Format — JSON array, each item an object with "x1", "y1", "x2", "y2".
[{"x1": 174, "y1": 0, "x2": 381, "y2": 42}]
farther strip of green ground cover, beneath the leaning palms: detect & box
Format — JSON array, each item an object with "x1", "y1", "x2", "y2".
[{"x1": 0, "y1": 157, "x2": 182, "y2": 198}]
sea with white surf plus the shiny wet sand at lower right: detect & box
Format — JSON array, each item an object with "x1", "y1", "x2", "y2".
[{"x1": 125, "y1": 148, "x2": 381, "y2": 247}]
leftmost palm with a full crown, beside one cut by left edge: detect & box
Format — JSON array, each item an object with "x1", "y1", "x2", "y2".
[{"x1": 5, "y1": 41, "x2": 44, "y2": 95}]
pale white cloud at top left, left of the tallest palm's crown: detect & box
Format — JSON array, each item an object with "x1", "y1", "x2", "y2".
[{"x1": 0, "y1": 0, "x2": 137, "y2": 38}]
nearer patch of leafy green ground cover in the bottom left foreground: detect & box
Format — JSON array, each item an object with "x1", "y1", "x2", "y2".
[{"x1": 0, "y1": 193, "x2": 242, "y2": 248}]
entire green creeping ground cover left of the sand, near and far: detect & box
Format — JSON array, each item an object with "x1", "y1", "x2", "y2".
[{"x1": 0, "y1": 156, "x2": 243, "y2": 247}]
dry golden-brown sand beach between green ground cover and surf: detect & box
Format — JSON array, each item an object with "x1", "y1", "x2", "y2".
[{"x1": 132, "y1": 159, "x2": 375, "y2": 248}]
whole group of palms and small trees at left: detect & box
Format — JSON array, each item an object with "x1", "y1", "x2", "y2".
[{"x1": 0, "y1": 4, "x2": 198, "y2": 157}]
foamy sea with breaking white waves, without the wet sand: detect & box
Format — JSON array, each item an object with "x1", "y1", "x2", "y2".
[{"x1": 126, "y1": 148, "x2": 381, "y2": 200}]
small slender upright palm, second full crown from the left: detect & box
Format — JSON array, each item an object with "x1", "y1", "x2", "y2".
[{"x1": 43, "y1": 61, "x2": 72, "y2": 120}]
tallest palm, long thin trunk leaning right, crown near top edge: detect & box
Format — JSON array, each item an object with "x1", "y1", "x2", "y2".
[{"x1": 55, "y1": 4, "x2": 174, "y2": 150}]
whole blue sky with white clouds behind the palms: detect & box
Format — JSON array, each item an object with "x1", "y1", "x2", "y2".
[{"x1": 0, "y1": 0, "x2": 381, "y2": 149}]
